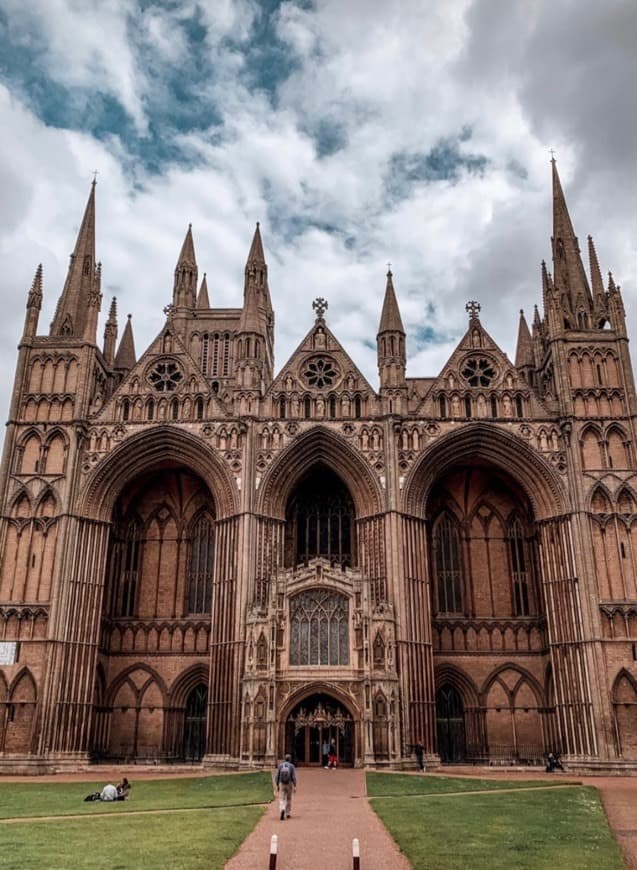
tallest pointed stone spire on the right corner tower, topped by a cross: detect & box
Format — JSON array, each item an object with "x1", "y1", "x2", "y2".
[{"x1": 551, "y1": 158, "x2": 593, "y2": 318}]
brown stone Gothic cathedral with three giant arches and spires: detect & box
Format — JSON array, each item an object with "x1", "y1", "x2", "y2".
[{"x1": 0, "y1": 161, "x2": 637, "y2": 773}]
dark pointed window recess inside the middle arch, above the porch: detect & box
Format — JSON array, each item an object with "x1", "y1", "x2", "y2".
[{"x1": 285, "y1": 467, "x2": 354, "y2": 567}]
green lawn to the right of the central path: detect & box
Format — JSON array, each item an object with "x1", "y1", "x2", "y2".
[{"x1": 367, "y1": 774, "x2": 624, "y2": 870}]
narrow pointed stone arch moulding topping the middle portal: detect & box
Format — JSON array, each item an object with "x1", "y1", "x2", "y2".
[{"x1": 257, "y1": 426, "x2": 382, "y2": 519}]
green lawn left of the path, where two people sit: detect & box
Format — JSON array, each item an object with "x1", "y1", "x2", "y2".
[{"x1": 0, "y1": 772, "x2": 272, "y2": 870}]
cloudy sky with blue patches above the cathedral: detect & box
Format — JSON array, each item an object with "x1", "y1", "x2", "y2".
[{"x1": 0, "y1": 0, "x2": 637, "y2": 430}]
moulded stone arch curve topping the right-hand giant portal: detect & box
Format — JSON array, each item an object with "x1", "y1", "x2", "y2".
[{"x1": 403, "y1": 423, "x2": 565, "y2": 520}]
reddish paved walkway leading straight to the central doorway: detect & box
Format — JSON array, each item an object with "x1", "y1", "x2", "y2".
[{"x1": 226, "y1": 768, "x2": 411, "y2": 870}]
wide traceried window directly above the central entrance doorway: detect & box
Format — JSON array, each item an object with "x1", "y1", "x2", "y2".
[{"x1": 290, "y1": 589, "x2": 349, "y2": 666}]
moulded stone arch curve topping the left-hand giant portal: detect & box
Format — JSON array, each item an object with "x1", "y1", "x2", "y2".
[{"x1": 79, "y1": 426, "x2": 239, "y2": 521}]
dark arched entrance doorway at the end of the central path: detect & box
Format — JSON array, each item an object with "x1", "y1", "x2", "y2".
[{"x1": 285, "y1": 694, "x2": 355, "y2": 767}]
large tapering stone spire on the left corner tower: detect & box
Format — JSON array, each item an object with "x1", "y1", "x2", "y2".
[{"x1": 50, "y1": 180, "x2": 102, "y2": 343}]
